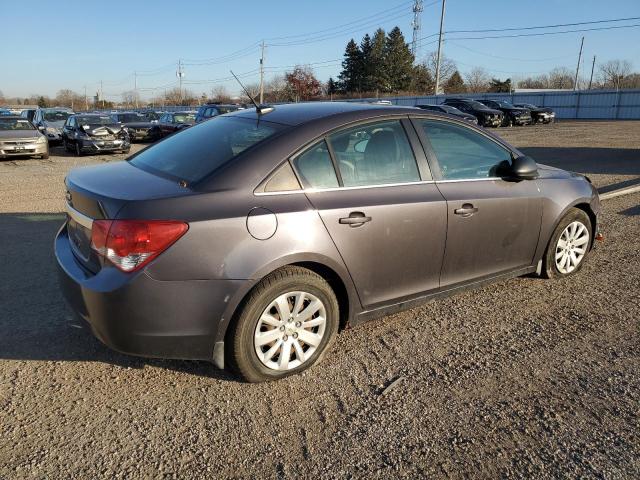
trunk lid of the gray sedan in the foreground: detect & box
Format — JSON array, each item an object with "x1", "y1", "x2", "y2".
[{"x1": 65, "y1": 162, "x2": 191, "y2": 273}]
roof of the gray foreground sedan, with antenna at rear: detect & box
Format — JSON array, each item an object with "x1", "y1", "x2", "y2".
[{"x1": 226, "y1": 102, "x2": 415, "y2": 126}]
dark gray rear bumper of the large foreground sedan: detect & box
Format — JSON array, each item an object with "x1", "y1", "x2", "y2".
[{"x1": 55, "y1": 225, "x2": 246, "y2": 360}]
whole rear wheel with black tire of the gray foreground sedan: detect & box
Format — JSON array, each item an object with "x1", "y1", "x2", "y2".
[{"x1": 225, "y1": 266, "x2": 340, "y2": 382}]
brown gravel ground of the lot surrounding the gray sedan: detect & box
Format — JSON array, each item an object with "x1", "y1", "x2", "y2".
[{"x1": 0, "y1": 122, "x2": 640, "y2": 479}]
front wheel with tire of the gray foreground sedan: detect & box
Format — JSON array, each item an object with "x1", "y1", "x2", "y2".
[{"x1": 542, "y1": 208, "x2": 593, "y2": 278}]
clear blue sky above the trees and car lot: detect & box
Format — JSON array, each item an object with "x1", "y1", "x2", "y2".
[{"x1": 0, "y1": 0, "x2": 640, "y2": 100}]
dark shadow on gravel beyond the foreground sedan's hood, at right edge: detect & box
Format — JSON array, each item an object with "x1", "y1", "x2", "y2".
[{"x1": 518, "y1": 147, "x2": 640, "y2": 175}]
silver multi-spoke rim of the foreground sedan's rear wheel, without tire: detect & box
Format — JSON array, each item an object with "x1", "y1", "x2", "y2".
[{"x1": 253, "y1": 291, "x2": 327, "y2": 370}]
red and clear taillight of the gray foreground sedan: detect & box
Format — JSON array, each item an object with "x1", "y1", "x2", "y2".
[{"x1": 91, "y1": 220, "x2": 189, "y2": 272}]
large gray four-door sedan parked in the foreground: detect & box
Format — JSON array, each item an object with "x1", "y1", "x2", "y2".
[{"x1": 55, "y1": 102, "x2": 600, "y2": 381}]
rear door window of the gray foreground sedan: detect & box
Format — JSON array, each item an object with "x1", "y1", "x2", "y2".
[{"x1": 329, "y1": 120, "x2": 420, "y2": 187}]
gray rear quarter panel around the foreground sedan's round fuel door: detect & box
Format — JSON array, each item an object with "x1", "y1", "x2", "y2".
[{"x1": 118, "y1": 191, "x2": 360, "y2": 331}]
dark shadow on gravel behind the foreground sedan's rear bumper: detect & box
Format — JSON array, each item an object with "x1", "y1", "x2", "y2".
[{"x1": 0, "y1": 213, "x2": 238, "y2": 381}]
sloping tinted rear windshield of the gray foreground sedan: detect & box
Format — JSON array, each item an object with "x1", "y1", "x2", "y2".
[{"x1": 130, "y1": 117, "x2": 285, "y2": 182}]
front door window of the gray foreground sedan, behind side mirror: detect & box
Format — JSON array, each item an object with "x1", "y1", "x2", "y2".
[{"x1": 419, "y1": 120, "x2": 511, "y2": 180}]
